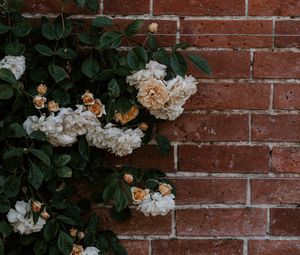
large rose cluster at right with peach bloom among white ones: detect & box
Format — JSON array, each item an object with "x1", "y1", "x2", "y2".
[{"x1": 126, "y1": 60, "x2": 197, "y2": 120}]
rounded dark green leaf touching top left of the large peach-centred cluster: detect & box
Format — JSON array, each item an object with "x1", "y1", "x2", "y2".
[{"x1": 127, "y1": 47, "x2": 148, "y2": 71}]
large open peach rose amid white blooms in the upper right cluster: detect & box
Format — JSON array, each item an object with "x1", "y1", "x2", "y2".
[{"x1": 137, "y1": 78, "x2": 169, "y2": 110}]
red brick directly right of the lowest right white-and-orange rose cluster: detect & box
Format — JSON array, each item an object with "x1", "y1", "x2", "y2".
[{"x1": 173, "y1": 179, "x2": 247, "y2": 204}]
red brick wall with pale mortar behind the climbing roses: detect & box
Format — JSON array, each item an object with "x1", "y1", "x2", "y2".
[{"x1": 24, "y1": 0, "x2": 300, "y2": 255}]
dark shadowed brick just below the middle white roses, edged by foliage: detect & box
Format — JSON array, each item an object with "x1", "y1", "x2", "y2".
[{"x1": 103, "y1": 145, "x2": 174, "y2": 172}]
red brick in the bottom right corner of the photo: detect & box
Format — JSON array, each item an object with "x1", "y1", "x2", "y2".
[{"x1": 248, "y1": 240, "x2": 300, "y2": 255}]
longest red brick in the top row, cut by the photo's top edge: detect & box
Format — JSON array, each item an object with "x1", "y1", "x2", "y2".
[{"x1": 154, "y1": 0, "x2": 245, "y2": 16}]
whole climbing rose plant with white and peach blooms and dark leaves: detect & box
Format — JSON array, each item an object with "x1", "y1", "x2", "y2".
[{"x1": 0, "y1": 0, "x2": 210, "y2": 255}]
